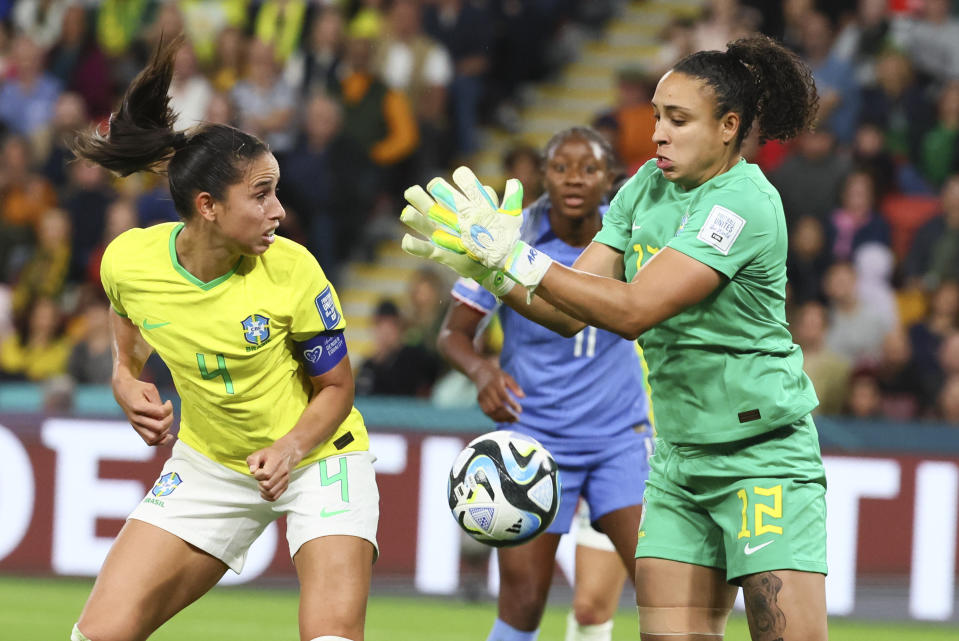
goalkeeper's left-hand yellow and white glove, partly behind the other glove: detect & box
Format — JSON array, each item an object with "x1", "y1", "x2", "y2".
[{"x1": 400, "y1": 185, "x2": 513, "y2": 297}]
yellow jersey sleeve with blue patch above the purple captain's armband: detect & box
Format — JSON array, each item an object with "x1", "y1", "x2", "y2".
[{"x1": 289, "y1": 250, "x2": 346, "y2": 341}]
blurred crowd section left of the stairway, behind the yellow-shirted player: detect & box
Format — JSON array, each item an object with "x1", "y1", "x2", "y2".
[{"x1": 0, "y1": 0, "x2": 616, "y2": 397}]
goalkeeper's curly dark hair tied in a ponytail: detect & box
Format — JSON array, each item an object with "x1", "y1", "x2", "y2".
[{"x1": 672, "y1": 35, "x2": 819, "y2": 145}]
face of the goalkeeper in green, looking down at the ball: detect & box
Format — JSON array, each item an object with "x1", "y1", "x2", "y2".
[{"x1": 653, "y1": 71, "x2": 739, "y2": 189}]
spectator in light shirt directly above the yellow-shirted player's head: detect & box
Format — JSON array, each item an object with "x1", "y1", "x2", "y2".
[{"x1": 232, "y1": 40, "x2": 296, "y2": 156}]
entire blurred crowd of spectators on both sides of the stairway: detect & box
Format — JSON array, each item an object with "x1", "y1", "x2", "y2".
[{"x1": 0, "y1": 0, "x2": 959, "y2": 424}]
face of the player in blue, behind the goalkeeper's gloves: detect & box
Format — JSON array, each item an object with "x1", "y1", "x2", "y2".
[{"x1": 545, "y1": 136, "x2": 612, "y2": 218}]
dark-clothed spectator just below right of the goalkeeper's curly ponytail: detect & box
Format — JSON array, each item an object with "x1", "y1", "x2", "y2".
[{"x1": 769, "y1": 127, "x2": 850, "y2": 227}]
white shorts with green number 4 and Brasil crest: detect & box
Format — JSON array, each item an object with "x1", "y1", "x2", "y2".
[{"x1": 129, "y1": 441, "x2": 380, "y2": 574}]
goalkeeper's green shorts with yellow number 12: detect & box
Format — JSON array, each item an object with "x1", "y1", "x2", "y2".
[{"x1": 636, "y1": 416, "x2": 826, "y2": 583}]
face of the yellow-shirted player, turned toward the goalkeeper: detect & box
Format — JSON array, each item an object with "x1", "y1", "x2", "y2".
[{"x1": 213, "y1": 153, "x2": 286, "y2": 255}]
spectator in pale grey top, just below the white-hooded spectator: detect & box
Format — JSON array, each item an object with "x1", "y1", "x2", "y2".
[{"x1": 824, "y1": 262, "x2": 893, "y2": 367}]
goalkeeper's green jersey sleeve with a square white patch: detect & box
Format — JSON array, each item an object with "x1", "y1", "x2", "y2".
[{"x1": 666, "y1": 182, "x2": 779, "y2": 278}]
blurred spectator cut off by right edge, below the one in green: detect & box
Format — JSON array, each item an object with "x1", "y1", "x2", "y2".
[{"x1": 902, "y1": 174, "x2": 959, "y2": 291}]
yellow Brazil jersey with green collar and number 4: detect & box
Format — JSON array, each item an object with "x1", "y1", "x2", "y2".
[{"x1": 100, "y1": 223, "x2": 369, "y2": 473}]
